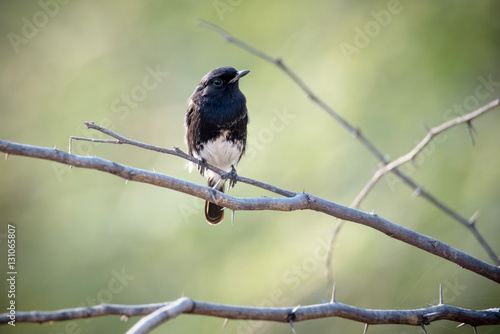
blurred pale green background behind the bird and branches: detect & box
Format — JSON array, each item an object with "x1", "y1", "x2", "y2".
[{"x1": 0, "y1": 0, "x2": 500, "y2": 334}]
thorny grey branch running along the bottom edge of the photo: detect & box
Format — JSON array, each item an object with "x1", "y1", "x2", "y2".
[{"x1": 0, "y1": 297, "x2": 500, "y2": 333}]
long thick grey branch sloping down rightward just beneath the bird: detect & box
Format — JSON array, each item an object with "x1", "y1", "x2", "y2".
[{"x1": 0, "y1": 139, "x2": 500, "y2": 283}]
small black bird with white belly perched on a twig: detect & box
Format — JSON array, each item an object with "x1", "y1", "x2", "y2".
[{"x1": 185, "y1": 66, "x2": 250, "y2": 225}]
